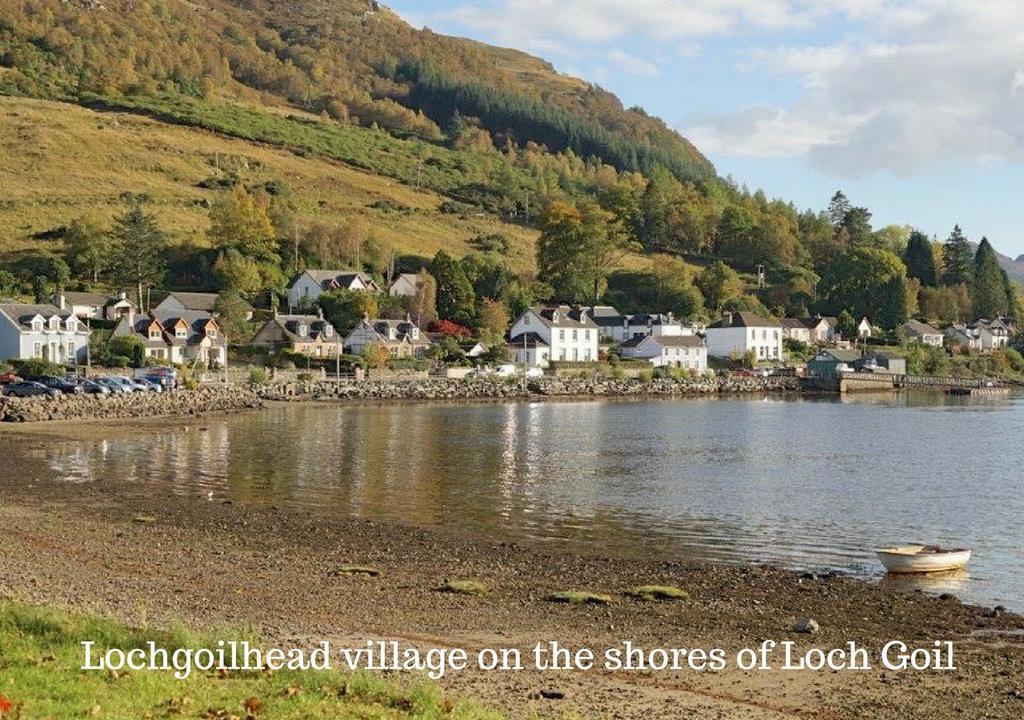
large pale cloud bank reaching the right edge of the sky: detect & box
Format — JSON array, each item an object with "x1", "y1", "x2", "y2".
[{"x1": 684, "y1": 0, "x2": 1024, "y2": 176}]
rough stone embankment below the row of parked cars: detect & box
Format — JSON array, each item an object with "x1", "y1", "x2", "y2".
[{"x1": 0, "y1": 386, "x2": 263, "y2": 423}]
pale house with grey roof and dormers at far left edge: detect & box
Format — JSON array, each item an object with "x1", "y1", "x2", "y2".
[{"x1": 0, "y1": 303, "x2": 89, "y2": 365}]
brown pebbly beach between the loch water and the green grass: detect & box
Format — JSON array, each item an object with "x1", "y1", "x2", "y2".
[{"x1": 0, "y1": 471, "x2": 1024, "y2": 720}]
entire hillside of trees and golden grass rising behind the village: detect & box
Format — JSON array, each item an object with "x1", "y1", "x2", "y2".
[{"x1": 0, "y1": 0, "x2": 1021, "y2": 344}]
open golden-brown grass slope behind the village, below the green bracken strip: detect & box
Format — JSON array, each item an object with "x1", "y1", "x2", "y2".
[{"x1": 0, "y1": 97, "x2": 537, "y2": 270}]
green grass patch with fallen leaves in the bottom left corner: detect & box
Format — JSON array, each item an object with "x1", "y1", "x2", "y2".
[{"x1": 0, "y1": 601, "x2": 500, "y2": 720}]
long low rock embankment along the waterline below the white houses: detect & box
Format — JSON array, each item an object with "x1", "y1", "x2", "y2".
[{"x1": 257, "y1": 377, "x2": 800, "y2": 400}]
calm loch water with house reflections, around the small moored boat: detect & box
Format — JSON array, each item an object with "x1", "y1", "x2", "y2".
[{"x1": 28, "y1": 393, "x2": 1024, "y2": 607}]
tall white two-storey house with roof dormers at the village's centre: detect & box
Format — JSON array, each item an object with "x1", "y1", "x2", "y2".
[{"x1": 509, "y1": 305, "x2": 599, "y2": 368}]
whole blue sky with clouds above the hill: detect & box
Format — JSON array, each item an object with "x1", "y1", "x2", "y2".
[{"x1": 386, "y1": 0, "x2": 1024, "y2": 257}]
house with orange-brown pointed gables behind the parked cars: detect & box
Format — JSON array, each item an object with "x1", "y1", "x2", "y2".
[{"x1": 113, "y1": 309, "x2": 227, "y2": 368}]
